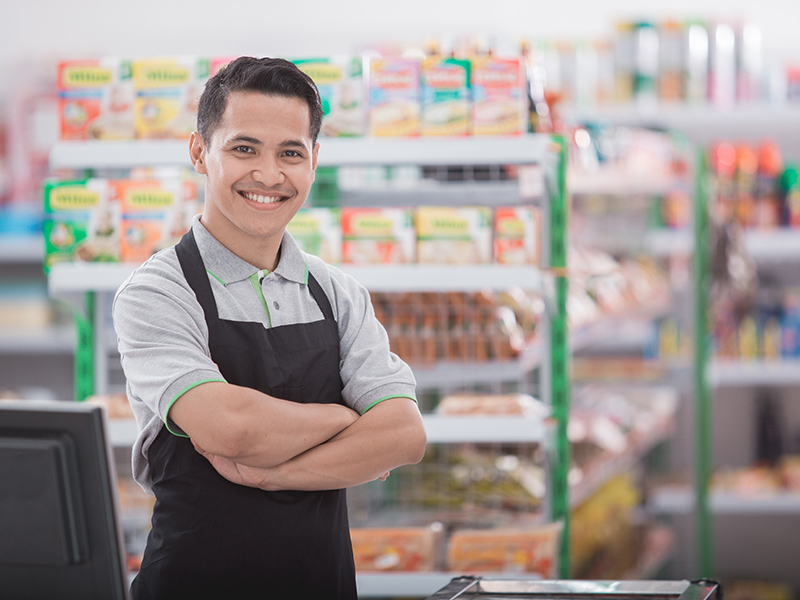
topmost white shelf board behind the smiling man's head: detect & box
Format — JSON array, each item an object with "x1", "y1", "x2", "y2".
[{"x1": 50, "y1": 135, "x2": 552, "y2": 169}]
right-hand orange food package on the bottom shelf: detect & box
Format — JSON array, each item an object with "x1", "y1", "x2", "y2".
[{"x1": 447, "y1": 522, "x2": 562, "y2": 579}]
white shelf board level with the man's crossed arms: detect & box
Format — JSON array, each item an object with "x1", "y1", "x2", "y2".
[{"x1": 108, "y1": 415, "x2": 549, "y2": 448}]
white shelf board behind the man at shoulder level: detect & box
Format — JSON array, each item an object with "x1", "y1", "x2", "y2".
[{"x1": 48, "y1": 263, "x2": 543, "y2": 294}]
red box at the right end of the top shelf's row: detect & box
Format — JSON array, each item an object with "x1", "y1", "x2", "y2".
[{"x1": 471, "y1": 56, "x2": 528, "y2": 135}]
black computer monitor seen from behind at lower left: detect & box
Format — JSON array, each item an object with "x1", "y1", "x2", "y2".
[{"x1": 0, "y1": 401, "x2": 129, "y2": 600}]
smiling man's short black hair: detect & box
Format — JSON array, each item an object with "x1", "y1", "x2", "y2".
[{"x1": 197, "y1": 56, "x2": 322, "y2": 144}]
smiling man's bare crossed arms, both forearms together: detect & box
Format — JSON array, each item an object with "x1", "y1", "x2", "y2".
[{"x1": 169, "y1": 382, "x2": 426, "y2": 491}]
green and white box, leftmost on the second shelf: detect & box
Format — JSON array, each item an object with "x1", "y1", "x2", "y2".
[{"x1": 42, "y1": 178, "x2": 120, "y2": 270}]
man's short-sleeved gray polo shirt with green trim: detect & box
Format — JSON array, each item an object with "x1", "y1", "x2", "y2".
[{"x1": 113, "y1": 217, "x2": 416, "y2": 491}]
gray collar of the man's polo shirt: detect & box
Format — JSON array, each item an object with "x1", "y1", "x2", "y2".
[{"x1": 192, "y1": 215, "x2": 308, "y2": 285}]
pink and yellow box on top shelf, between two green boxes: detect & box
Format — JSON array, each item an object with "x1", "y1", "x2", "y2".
[{"x1": 367, "y1": 57, "x2": 422, "y2": 137}]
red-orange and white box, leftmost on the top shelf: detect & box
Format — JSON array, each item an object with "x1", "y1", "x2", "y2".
[{"x1": 57, "y1": 58, "x2": 136, "y2": 140}]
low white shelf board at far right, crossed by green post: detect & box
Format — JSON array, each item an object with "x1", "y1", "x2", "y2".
[{"x1": 648, "y1": 486, "x2": 800, "y2": 515}]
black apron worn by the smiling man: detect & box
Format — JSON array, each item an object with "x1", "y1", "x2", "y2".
[{"x1": 132, "y1": 230, "x2": 356, "y2": 600}]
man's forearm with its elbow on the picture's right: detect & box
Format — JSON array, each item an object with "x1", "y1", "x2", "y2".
[{"x1": 261, "y1": 398, "x2": 426, "y2": 491}]
